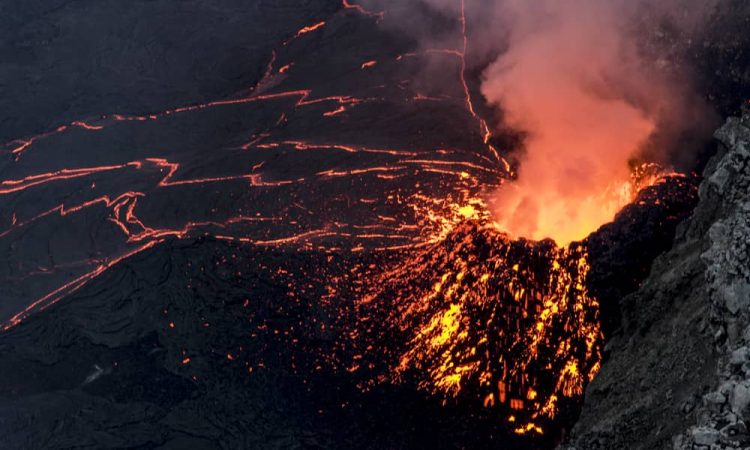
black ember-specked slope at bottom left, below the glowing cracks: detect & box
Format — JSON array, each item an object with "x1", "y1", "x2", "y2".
[{"x1": 0, "y1": 239, "x2": 525, "y2": 449}]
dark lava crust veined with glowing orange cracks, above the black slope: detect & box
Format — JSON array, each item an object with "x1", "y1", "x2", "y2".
[{"x1": 0, "y1": 0, "x2": 504, "y2": 323}]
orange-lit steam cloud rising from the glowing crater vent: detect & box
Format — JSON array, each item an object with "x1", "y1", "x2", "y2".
[{"x1": 412, "y1": 0, "x2": 715, "y2": 244}]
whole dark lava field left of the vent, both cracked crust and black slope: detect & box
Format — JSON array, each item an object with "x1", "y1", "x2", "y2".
[{"x1": 0, "y1": 0, "x2": 507, "y2": 449}]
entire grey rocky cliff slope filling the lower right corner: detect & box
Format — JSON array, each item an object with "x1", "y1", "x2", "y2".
[{"x1": 567, "y1": 106, "x2": 750, "y2": 450}]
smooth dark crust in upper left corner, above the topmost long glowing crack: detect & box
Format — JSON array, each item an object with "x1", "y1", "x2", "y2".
[{"x1": 0, "y1": 0, "x2": 339, "y2": 142}]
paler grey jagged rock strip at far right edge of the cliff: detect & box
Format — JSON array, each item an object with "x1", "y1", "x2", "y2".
[{"x1": 674, "y1": 108, "x2": 750, "y2": 450}]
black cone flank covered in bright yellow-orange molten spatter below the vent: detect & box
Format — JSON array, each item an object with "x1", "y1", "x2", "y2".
[{"x1": 362, "y1": 221, "x2": 601, "y2": 434}]
